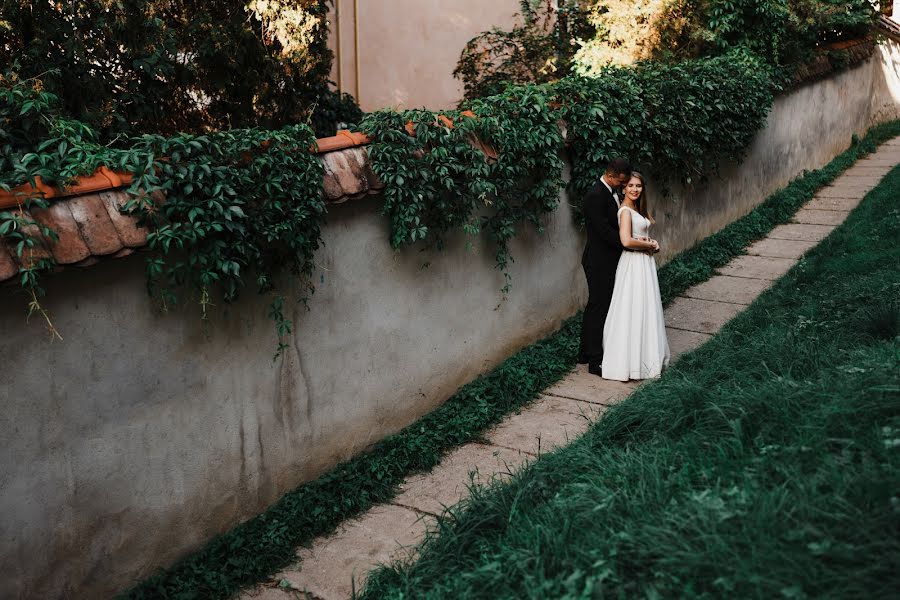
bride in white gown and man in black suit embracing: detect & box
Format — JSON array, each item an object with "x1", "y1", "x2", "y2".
[{"x1": 578, "y1": 158, "x2": 669, "y2": 381}]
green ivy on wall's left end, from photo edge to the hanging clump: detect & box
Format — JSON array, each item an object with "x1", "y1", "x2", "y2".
[{"x1": 0, "y1": 75, "x2": 325, "y2": 352}]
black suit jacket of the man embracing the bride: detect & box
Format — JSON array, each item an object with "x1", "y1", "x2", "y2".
[{"x1": 581, "y1": 180, "x2": 624, "y2": 273}]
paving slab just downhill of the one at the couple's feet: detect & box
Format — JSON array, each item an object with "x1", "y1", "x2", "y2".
[{"x1": 486, "y1": 394, "x2": 604, "y2": 454}]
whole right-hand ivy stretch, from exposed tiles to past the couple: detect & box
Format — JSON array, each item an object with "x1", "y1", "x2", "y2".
[{"x1": 361, "y1": 52, "x2": 775, "y2": 286}]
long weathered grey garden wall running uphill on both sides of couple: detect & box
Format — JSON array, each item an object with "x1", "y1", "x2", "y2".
[{"x1": 0, "y1": 46, "x2": 898, "y2": 600}]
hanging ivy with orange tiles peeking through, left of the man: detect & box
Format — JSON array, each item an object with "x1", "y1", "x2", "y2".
[{"x1": 361, "y1": 86, "x2": 563, "y2": 289}]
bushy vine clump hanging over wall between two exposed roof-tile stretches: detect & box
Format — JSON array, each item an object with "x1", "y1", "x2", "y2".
[{"x1": 124, "y1": 125, "x2": 325, "y2": 352}]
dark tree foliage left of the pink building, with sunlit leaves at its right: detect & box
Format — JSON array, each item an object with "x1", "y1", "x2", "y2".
[{"x1": 0, "y1": 0, "x2": 361, "y2": 139}]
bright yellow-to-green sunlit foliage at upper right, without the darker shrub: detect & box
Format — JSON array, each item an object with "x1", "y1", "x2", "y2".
[{"x1": 574, "y1": 0, "x2": 877, "y2": 75}]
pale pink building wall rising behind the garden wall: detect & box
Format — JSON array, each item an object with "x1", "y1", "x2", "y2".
[{"x1": 329, "y1": 0, "x2": 519, "y2": 111}]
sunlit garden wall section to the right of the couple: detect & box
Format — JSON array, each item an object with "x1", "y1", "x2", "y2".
[{"x1": 649, "y1": 42, "x2": 900, "y2": 262}]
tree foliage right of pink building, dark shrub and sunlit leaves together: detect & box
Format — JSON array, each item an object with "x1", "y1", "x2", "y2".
[{"x1": 454, "y1": 0, "x2": 877, "y2": 99}]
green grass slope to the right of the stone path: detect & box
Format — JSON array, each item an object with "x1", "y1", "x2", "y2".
[{"x1": 363, "y1": 168, "x2": 900, "y2": 600}]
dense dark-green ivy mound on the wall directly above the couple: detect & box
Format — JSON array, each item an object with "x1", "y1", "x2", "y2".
[{"x1": 555, "y1": 53, "x2": 775, "y2": 198}]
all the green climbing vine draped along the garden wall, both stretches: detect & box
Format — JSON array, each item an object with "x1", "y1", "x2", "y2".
[{"x1": 0, "y1": 35, "x2": 864, "y2": 343}]
